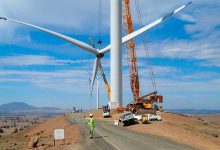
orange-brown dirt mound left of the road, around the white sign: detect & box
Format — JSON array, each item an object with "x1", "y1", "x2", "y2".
[{"x1": 0, "y1": 116, "x2": 82, "y2": 150}]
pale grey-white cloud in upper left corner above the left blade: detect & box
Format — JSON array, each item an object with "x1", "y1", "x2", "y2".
[{"x1": 1, "y1": 0, "x2": 108, "y2": 31}]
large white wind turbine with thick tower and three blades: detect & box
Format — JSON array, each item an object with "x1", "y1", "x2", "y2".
[{"x1": 0, "y1": 0, "x2": 191, "y2": 108}]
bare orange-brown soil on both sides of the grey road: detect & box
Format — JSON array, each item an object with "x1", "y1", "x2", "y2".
[{"x1": 0, "y1": 110, "x2": 220, "y2": 150}]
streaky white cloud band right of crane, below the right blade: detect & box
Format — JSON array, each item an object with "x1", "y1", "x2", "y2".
[{"x1": 137, "y1": 31, "x2": 220, "y2": 66}]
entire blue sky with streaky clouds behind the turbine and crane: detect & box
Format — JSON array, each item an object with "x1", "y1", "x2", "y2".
[{"x1": 0, "y1": 0, "x2": 220, "y2": 109}]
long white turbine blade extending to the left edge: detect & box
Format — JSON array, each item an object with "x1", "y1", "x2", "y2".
[{"x1": 0, "y1": 17, "x2": 98, "y2": 55}]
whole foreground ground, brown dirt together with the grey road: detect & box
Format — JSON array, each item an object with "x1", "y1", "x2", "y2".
[{"x1": 0, "y1": 110, "x2": 220, "y2": 150}]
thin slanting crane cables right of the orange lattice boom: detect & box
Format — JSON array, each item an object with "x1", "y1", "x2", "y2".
[{"x1": 135, "y1": 0, "x2": 157, "y2": 91}]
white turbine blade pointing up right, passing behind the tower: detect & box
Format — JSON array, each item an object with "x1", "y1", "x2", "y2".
[{"x1": 100, "y1": 2, "x2": 192, "y2": 54}]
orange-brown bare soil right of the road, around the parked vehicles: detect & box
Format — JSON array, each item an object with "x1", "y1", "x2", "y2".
[{"x1": 87, "y1": 110, "x2": 220, "y2": 150}]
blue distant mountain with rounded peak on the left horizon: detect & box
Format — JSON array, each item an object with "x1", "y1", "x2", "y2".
[{"x1": 0, "y1": 102, "x2": 71, "y2": 115}]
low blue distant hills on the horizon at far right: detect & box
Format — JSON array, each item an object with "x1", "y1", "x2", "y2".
[{"x1": 166, "y1": 109, "x2": 220, "y2": 115}]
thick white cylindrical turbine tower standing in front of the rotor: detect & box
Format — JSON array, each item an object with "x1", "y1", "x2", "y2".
[{"x1": 110, "y1": 0, "x2": 123, "y2": 109}]
